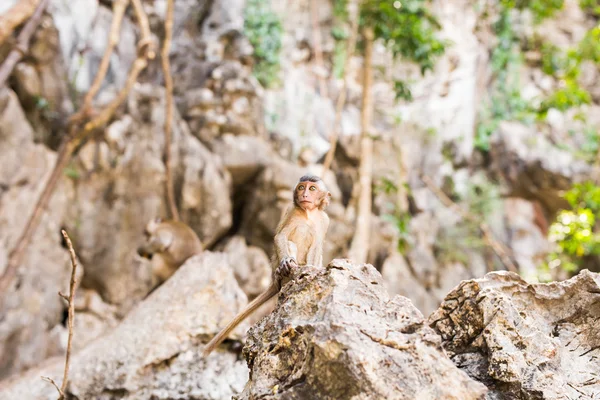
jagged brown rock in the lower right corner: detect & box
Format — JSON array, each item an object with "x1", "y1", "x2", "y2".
[{"x1": 429, "y1": 270, "x2": 600, "y2": 399}]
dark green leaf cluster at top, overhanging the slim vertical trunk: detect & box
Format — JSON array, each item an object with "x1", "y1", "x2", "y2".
[{"x1": 360, "y1": 0, "x2": 447, "y2": 74}]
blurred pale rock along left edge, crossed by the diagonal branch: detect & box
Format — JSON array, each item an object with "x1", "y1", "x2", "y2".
[{"x1": 0, "y1": 88, "x2": 73, "y2": 379}]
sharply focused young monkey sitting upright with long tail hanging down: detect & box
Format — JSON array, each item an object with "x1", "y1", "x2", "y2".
[{"x1": 203, "y1": 175, "x2": 331, "y2": 356}]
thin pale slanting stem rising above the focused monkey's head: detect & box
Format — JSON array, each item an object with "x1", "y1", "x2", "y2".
[{"x1": 321, "y1": 1, "x2": 360, "y2": 176}]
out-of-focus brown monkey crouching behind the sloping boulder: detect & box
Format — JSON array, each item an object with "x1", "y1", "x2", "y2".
[{"x1": 137, "y1": 218, "x2": 203, "y2": 287}]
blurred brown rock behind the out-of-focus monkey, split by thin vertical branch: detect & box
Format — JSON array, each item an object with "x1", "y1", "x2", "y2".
[{"x1": 68, "y1": 85, "x2": 232, "y2": 312}]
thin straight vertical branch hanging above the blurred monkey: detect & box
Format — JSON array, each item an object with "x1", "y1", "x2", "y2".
[{"x1": 161, "y1": 0, "x2": 180, "y2": 221}]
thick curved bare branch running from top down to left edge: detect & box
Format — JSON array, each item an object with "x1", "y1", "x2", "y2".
[{"x1": 0, "y1": 0, "x2": 155, "y2": 293}]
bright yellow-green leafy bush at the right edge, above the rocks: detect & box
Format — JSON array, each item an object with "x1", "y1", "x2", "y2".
[{"x1": 545, "y1": 182, "x2": 600, "y2": 272}]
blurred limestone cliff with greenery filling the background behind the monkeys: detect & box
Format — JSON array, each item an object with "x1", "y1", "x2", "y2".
[{"x1": 0, "y1": 0, "x2": 600, "y2": 379}]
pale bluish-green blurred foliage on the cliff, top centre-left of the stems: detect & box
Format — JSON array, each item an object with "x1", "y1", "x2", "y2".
[{"x1": 244, "y1": 0, "x2": 283, "y2": 87}]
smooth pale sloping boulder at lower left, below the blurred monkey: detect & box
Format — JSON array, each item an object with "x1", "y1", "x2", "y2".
[{"x1": 0, "y1": 252, "x2": 248, "y2": 400}]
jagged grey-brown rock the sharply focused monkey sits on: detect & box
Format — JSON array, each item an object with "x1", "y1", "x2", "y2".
[{"x1": 238, "y1": 260, "x2": 486, "y2": 400}]
